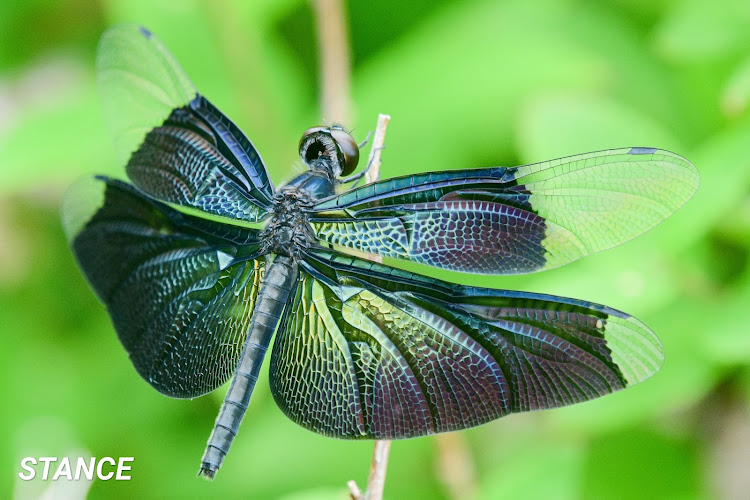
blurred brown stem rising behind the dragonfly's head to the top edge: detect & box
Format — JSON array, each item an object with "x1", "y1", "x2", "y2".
[{"x1": 313, "y1": 0, "x2": 352, "y2": 124}]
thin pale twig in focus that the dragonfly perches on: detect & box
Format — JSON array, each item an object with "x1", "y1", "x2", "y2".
[{"x1": 347, "y1": 114, "x2": 391, "y2": 500}]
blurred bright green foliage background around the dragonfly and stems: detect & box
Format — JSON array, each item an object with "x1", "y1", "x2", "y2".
[{"x1": 0, "y1": 0, "x2": 750, "y2": 500}]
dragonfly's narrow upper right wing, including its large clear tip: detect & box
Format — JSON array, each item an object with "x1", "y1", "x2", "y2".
[{"x1": 310, "y1": 148, "x2": 700, "y2": 274}]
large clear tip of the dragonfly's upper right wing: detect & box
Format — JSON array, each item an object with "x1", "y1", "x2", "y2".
[{"x1": 517, "y1": 147, "x2": 700, "y2": 269}]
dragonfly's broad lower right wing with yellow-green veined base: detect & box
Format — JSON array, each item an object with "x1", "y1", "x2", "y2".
[{"x1": 270, "y1": 249, "x2": 663, "y2": 439}]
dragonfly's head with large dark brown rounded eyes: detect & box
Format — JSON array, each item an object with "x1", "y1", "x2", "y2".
[{"x1": 299, "y1": 125, "x2": 359, "y2": 177}]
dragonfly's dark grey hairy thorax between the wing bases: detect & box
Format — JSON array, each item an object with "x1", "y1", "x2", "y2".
[{"x1": 259, "y1": 187, "x2": 315, "y2": 259}]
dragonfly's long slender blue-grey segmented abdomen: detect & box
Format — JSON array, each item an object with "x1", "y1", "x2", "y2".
[{"x1": 198, "y1": 255, "x2": 297, "y2": 479}]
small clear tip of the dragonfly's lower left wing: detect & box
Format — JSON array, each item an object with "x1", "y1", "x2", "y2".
[{"x1": 60, "y1": 177, "x2": 107, "y2": 243}]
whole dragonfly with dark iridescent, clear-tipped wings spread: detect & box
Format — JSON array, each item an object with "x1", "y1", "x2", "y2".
[{"x1": 62, "y1": 25, "x2": 699, "y2": 479}]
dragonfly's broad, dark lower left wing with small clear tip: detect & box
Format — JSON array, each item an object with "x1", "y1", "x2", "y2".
[{"x1": 62, "y1": 177, "x2": 265, "y2": 398}]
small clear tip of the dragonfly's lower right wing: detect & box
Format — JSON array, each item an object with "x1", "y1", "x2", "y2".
[{"x1": 604, "y1": 311, "x2": 664, "y2": 387}]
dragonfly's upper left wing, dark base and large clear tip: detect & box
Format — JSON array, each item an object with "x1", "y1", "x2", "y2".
[{"x1": 96, "y1": 25, "x2": 274, "y2": 222}]
